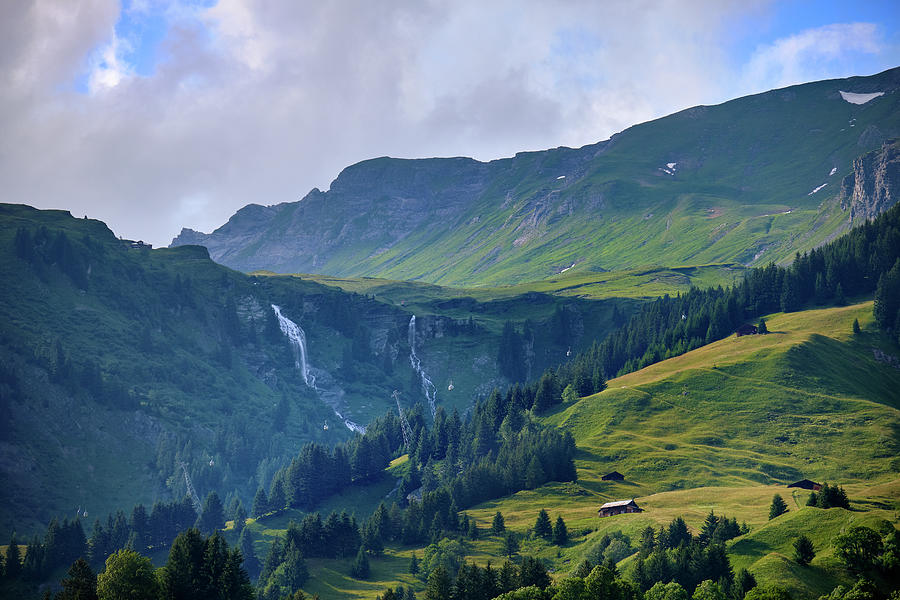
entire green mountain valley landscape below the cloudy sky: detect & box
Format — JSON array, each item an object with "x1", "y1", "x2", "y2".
[{"x1": 0, "y1": 68, "x2": 900, "y2": 600}]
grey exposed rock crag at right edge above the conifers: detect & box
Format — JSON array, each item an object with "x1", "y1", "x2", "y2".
[{"x1": 840, "y1": 139, "x2": 900, "y2": 225}]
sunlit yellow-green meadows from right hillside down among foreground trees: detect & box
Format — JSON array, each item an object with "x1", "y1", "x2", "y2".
[{"x1": 250, "y1": 302, "x2": 900, "y2": 599}]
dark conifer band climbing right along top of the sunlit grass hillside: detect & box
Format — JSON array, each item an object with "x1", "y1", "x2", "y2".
[{"x1": 545, "y1": 205, "x2": 900, "y2": 384}]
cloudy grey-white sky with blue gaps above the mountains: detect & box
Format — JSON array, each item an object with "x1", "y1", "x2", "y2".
[{"x1": 0, "y1": 0, "x2": 900, "y2": 245}]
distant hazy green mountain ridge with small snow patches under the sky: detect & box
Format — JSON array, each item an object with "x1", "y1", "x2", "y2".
[{"x1": 173, "y1": 69, "x2": 900, "y2": 286}]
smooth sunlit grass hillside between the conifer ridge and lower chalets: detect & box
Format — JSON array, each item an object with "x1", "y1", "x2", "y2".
[{"x1": 548, "y1": 303, "x2": 900, "y2": 491}]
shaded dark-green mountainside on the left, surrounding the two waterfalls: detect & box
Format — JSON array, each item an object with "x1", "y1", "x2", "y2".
[{"x1": 0, "y1": 204, "x2": 624, "y2": 538}]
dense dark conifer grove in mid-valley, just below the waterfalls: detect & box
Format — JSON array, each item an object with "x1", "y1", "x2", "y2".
[{"x1": 260, "y1": 386, "x2": 576, "y2": 530}]
